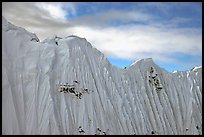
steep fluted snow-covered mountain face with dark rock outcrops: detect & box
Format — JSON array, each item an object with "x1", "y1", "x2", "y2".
[{"x1": 2, "y1": 17, "x2": 202, "y2": 135}]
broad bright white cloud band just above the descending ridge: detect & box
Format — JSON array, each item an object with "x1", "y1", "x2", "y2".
[{"x1": 71, "y1": 25, "x2": 202, "y2": 62}]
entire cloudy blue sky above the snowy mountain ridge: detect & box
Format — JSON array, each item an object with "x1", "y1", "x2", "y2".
[{"x1": 2, "y1": 2, "x2": 202, "y2": 72}]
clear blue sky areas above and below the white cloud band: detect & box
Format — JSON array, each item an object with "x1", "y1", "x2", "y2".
[{"x1": 69, "y1": 2, "x2": 202, "y2": 72}]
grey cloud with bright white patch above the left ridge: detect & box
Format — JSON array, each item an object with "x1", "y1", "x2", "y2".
[{"x1": 2, "y1": 2, "x2": 76, "y2": 40}]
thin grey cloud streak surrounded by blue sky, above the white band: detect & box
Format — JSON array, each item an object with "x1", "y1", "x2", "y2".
[{"x1": 72, "y1": 10, "x2": 152, "y2": 27}]
